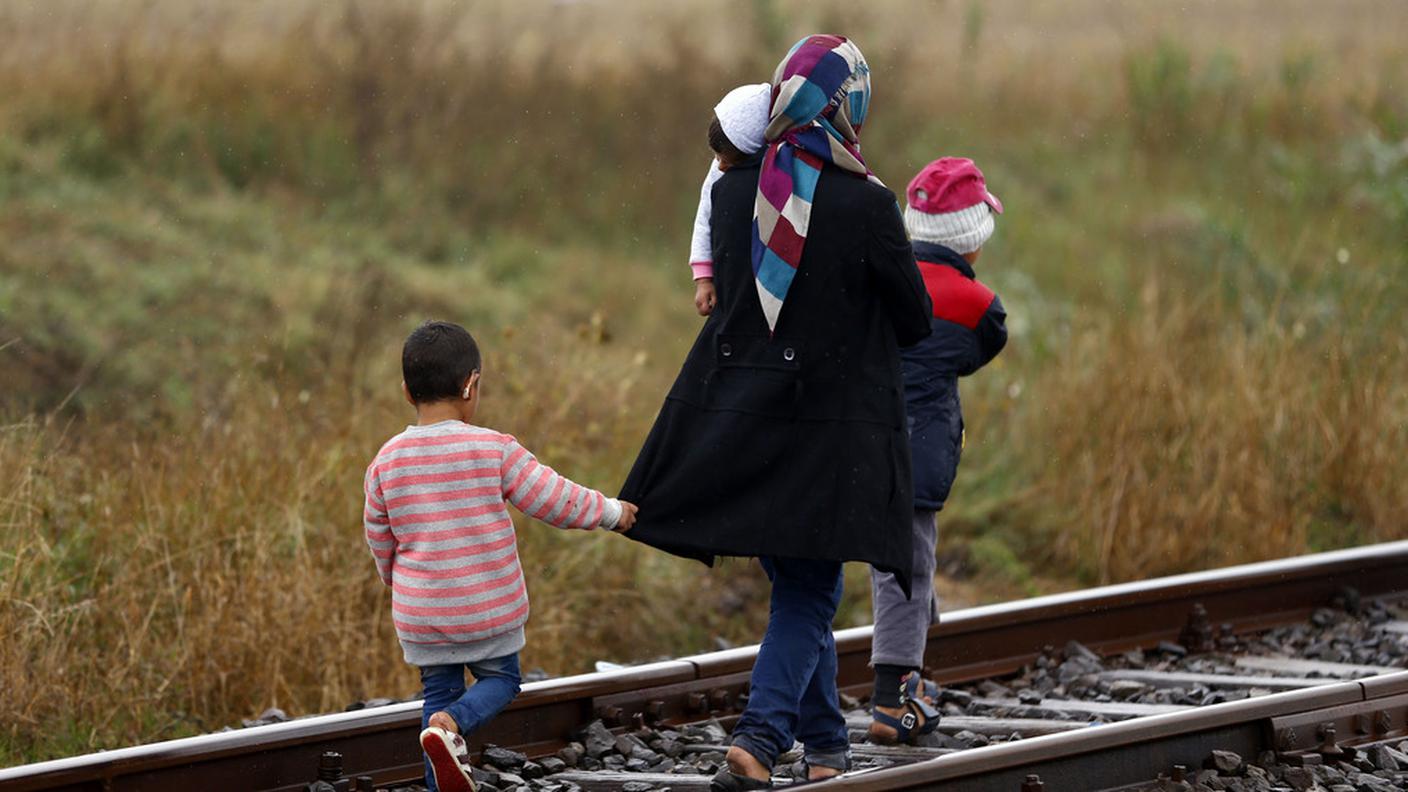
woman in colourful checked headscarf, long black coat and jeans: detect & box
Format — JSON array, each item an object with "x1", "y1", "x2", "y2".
[{"x1": 621, "y1": 35, "x2": 931, "y2": 788}]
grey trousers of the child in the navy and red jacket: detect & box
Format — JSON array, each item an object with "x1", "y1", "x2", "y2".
[{"x1": 870, "y1": 510, "x2": 939, "y2": 668}]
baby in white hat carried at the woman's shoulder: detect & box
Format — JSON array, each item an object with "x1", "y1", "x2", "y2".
[{"x1": 690, "y1": 83, "x2": 773, "y2": 316}]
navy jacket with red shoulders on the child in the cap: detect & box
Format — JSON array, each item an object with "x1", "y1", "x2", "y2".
[{"x1": 900, "y1": 241, "x2": 1007, "y2": 510}]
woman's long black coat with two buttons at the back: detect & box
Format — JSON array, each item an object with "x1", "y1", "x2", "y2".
[{"x1": 621, "y1": 165, "x2": 931, "y2": 589}]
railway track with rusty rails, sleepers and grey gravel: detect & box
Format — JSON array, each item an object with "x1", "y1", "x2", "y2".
[{"x1": 0, "y1": 541, "x2": 1408, "y2": 792}]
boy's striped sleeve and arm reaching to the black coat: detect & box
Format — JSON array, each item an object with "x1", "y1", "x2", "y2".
[{"x1": 498, "y1": 435, "x2": 635, "y2": 531}]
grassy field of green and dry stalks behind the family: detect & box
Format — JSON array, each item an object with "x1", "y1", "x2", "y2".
[{"x1": 0, "y1": 3, "x2": 1408, "y2": 764}]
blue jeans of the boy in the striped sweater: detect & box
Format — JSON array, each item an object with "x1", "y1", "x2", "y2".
[{"x1": 421, "y1": 652, "x2": 522, "y2": 792}]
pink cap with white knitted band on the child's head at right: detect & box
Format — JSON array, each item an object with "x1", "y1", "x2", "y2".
[{"x1": 904, "y1": 156, "x2": 1002, "y2": 254}]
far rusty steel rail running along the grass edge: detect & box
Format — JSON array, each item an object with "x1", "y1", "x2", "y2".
[{"x1": 8, "y1": 541, "x2": 1408, "y2": 792}]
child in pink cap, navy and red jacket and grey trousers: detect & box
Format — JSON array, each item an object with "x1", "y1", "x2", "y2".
[{"x1": 869, "y1": 156, "x2": 1007, "y2": 743}]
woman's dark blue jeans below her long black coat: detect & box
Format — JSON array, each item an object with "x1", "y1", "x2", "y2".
[{"x1": 734, "y1": 558, "x2": 850, "y2": 769}]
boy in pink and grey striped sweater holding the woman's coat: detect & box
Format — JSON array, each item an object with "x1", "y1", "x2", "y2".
[{"x1": 363, "y1": 321, "x2": 636, "y2": 792}]
